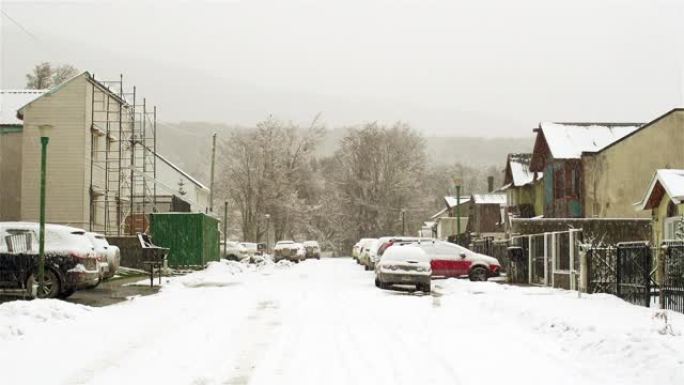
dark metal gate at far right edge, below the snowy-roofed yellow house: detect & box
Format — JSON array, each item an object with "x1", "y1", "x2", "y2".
[{"x1": 660, "y1": 241, "x2": 684, "y2": 313}]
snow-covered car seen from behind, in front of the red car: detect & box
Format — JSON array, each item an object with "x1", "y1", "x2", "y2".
[{"x1": 375, "y1": 245, "x2": 432, "y2": 293}]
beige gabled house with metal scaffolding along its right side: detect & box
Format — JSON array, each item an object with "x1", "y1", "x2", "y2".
[{"x1": 17, "y1": 72, "x2": 156, "y2": 235}]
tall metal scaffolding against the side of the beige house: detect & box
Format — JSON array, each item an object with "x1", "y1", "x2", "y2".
[{"x1": 90, "y1": 75, "x2": 157, "y2": 236}]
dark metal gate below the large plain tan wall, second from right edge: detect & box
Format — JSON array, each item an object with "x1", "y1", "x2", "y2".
[{"x1": 616, "y1": 242, "x2": 656, "y2": 307}]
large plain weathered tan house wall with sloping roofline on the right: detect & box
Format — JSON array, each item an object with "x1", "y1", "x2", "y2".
[{"x1": 582, "y1": 110, "x2": 684, "y2": 218}]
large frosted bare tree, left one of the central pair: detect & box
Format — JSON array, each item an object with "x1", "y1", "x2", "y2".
[{"x1": 219, "y1": 118, "x2": 324, "y2": 241}]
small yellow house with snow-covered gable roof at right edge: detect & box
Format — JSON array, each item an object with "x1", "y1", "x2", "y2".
[{"x1": 638, "y1": 169, "x2": 684, "y2": 245}]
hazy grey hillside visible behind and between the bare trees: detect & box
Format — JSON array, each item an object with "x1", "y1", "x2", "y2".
[{"x1": 157, "y1": 122, "x2": 534, "y2": 184}]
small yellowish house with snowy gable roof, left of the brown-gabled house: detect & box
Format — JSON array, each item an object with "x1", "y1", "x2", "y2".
[{"x1": 501, "y1": 154, "x2": 544, "y2": 218}]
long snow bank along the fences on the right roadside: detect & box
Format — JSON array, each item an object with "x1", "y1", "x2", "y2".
[{"x1": 436, "y1": 279, "x2": 684, "y2": 383}]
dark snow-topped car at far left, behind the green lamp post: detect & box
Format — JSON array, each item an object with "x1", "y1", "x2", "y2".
[{"x1": 0, "y1": 222, "x2": 100, "y2": 298}]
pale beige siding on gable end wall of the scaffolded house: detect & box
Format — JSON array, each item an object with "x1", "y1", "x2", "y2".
[{"x1": 21, "y1": 77, "x2": 90, "y2": 228}]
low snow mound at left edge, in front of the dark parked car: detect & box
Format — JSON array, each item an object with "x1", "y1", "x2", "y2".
[{"x1": 0, "y1": 299, "x2": 92, "y2": 341}]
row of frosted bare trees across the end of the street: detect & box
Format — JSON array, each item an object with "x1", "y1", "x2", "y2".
[{"x1": 216, "y1": 117, "x2": 502, "y2": 252}]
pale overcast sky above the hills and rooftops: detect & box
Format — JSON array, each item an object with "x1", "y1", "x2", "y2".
[{"x1": 0, "y1": 0, "x2": 684, "y2": 136}]
